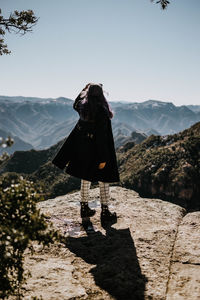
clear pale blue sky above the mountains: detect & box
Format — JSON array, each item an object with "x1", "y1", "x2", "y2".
[{"x1": 0, "y1": 0, "x2": 200, "y2": 105}]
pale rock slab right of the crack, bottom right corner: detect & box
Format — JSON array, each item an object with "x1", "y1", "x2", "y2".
[{"x1": 167, "y1": 212, "x2": 200, "y2": 300}]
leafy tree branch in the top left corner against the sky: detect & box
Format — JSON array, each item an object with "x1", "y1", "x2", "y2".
[{"x1": 0, "y1": 9, "x2": 38, "y2": 55}]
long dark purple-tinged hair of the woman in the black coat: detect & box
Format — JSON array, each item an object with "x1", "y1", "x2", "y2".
[{"x1": 80, "y1": 83, "x2": 113, "y2": 120}]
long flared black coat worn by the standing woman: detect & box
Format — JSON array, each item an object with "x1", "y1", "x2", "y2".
[{"x1": 52, "y1": 101, "x2": 120, "y2": 182}]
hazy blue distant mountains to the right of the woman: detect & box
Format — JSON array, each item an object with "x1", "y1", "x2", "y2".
[{"x1": 111, "y1": 100, "x2": 200, "y2": 135}]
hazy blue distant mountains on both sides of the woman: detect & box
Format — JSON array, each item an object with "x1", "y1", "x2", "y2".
[{"x1": 0, "y1": 96, "x2": 200, "y2": 150}]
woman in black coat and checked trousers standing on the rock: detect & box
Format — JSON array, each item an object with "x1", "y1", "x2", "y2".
[{"x1": 52, "y1": 83, "x2": 120, "y2": 221}]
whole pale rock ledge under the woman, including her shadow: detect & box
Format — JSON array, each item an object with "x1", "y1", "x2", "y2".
[{"x1": 20, "y1": 186, "x2": 200, "y2": 300}]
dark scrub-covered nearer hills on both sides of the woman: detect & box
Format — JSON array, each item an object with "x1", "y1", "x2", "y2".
[{"x1": 1, "y1": 122, "x2": 200, "y2": 210}]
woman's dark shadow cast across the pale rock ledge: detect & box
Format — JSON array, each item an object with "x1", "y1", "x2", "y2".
[{"x1": 66, "y1": 227, "x2": 147, "y2": 300}]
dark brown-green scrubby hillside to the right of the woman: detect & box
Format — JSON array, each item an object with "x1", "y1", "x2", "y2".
[{"x1": 118, "y1": 122, "x2": 200, "y2": 210}]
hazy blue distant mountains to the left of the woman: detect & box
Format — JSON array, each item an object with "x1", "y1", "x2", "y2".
[{"x1": 0, "y1": 96, "x2": 77, "y2": 149}]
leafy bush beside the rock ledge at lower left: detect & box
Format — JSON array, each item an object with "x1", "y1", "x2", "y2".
[{"x1": 0, "y1": 177, "x2": 59, "y2": 299}]
